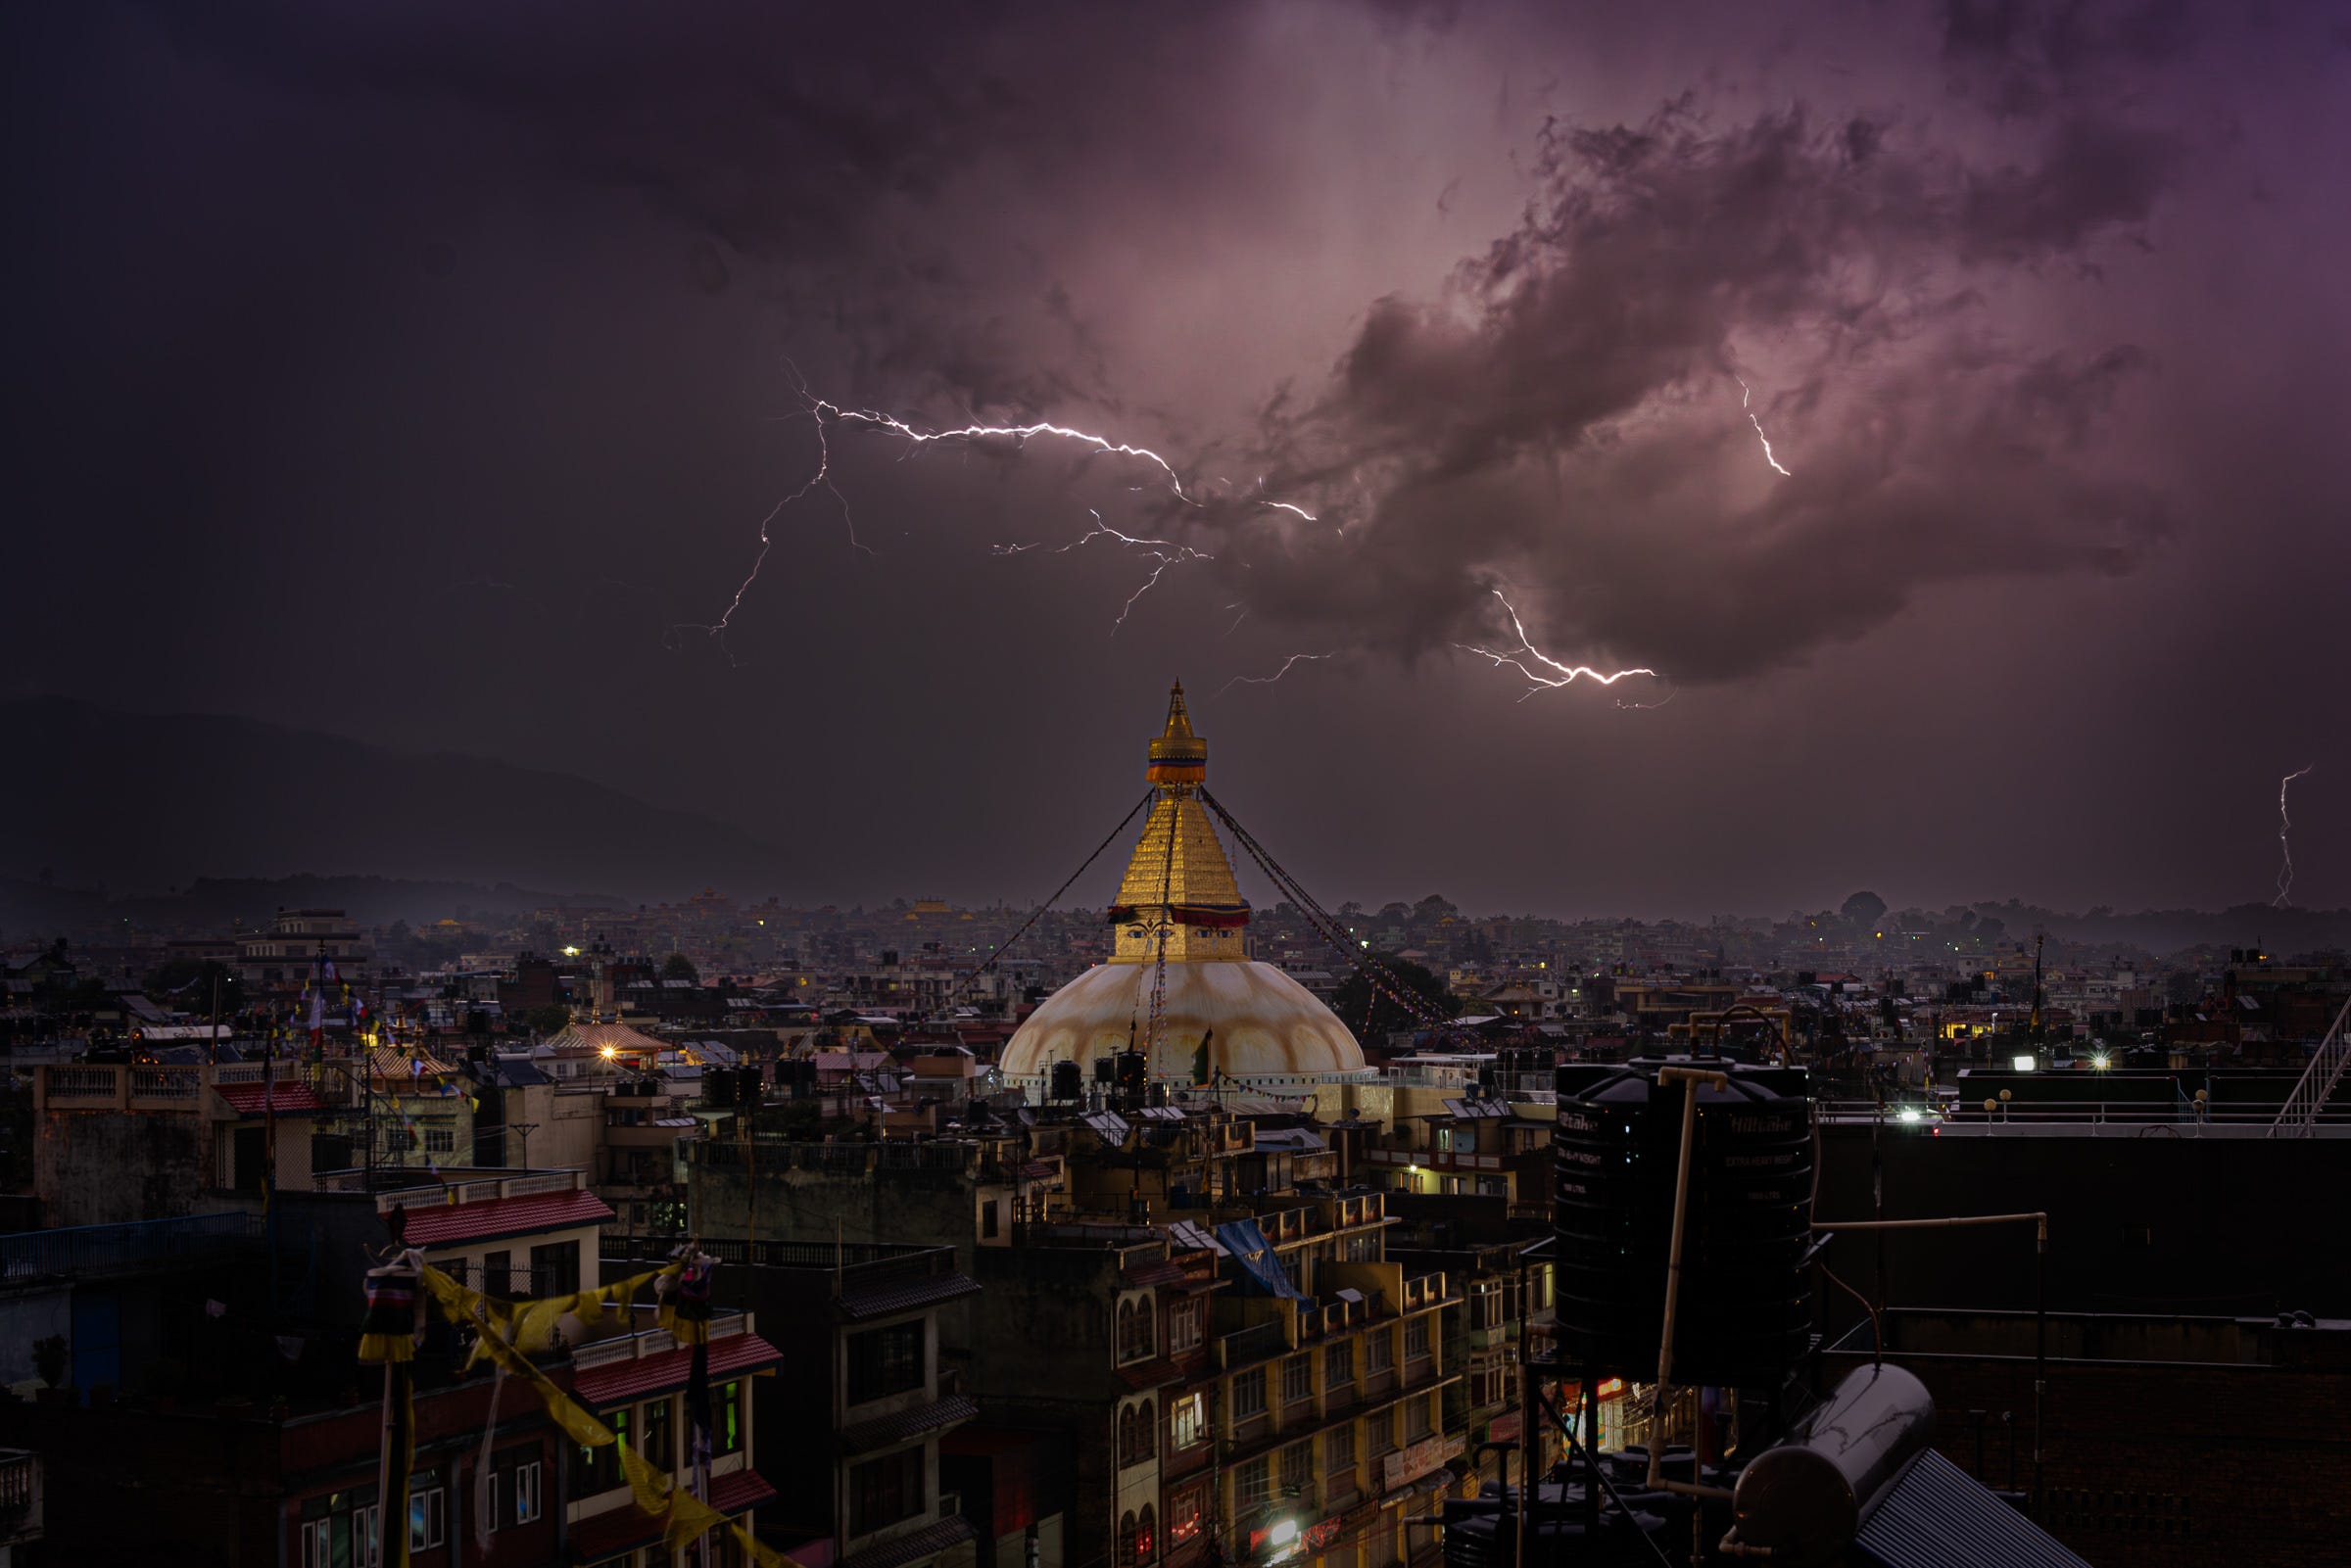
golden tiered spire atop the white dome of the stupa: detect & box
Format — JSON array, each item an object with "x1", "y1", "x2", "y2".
[{"x1": 1112, "y1": 682, "x2": 1248, "y2": 959}]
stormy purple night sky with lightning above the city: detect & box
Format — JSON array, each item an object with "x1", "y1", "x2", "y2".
[{"x1": 0, "y1": 0, "x2": 2351, "y2": 915}]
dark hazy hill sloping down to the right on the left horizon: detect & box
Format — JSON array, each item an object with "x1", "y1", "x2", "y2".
[{"x1": 0, "y1": 698, "x2": 794, "y2": 900}]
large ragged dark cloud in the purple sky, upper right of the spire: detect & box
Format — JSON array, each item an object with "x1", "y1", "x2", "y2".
[{"x1": 1203, "y1": 104, "x2": 2177, "y2": 680}]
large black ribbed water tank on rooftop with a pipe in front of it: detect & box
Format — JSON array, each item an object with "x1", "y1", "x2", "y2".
[{"x1": 1552, "y1": 1058, "x2": 1812, "y2": 1387}]
